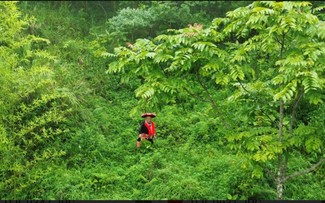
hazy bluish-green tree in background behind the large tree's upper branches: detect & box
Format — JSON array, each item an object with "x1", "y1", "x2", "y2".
[{"x1": 107, "y1": 1, "x2": 248, "y2": 47}]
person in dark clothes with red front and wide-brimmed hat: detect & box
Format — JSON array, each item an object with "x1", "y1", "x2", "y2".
[{"x1": 137, "y1": 113, "x2": 156, "y2": 148}]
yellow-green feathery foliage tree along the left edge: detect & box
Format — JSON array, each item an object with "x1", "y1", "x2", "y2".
[{"x1": 0, "y1": 2, "x2": 74, "y2": 199}]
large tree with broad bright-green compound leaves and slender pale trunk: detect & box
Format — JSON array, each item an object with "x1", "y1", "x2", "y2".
[{"x1": 106, "y1": 2, "x2": 325, "y2": 199}]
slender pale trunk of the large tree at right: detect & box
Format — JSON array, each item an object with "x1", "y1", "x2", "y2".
[{"x1": 276, "y1": 100, "x2": 284, "y2": 200}]
